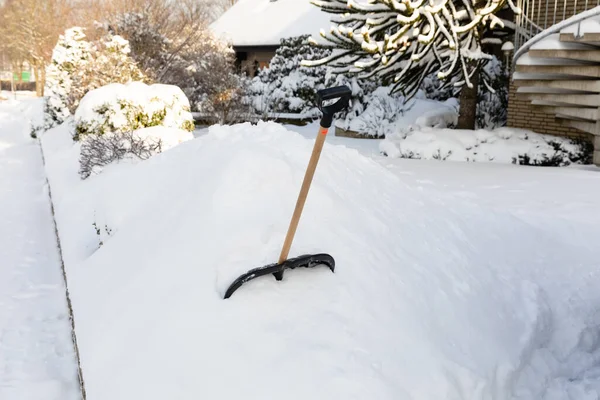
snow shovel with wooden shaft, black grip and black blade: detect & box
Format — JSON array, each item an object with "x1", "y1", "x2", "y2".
[{"x1": 225, "y1": 86, "x2": 352, "y2": 299}]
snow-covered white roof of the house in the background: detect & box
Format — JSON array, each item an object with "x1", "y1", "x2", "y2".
[{"x1": 210, "y1": 0, "x2": 332, "y2": 46}]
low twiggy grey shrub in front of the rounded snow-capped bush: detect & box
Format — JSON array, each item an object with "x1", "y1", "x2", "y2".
[{"x1": 79, "y1": 126, "x2": 193, "y2": 179}]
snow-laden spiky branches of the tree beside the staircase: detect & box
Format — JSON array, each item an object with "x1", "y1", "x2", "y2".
[{"x1": 303, "y1": 0, "x2": 520, "y2": 99}]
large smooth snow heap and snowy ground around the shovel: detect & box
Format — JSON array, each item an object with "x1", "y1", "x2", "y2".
[{"x1": 42, "y1": 117, "x2": 600, "y2": 400}]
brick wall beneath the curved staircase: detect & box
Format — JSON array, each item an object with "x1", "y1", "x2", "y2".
[{"x1": 507, "y1": 82, "x2": 593, "y2": 142}]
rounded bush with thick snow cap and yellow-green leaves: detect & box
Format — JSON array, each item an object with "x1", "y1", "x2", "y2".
[{"x1": 74, "y1": 82, "x2": 194, "y2": 140}]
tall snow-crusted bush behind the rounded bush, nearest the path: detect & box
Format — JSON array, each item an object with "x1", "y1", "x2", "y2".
[{"x1": 44, "y1": 27, "x2": 145, "y2": 129}]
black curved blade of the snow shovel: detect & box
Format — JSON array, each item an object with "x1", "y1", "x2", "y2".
[{"x1": 224, "y1": 254, "x2": 335, "y2": 299}]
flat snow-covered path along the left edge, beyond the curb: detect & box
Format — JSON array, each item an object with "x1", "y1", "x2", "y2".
[{"x1": 0, "y1": 98, "x2": 79, "y2": 400}]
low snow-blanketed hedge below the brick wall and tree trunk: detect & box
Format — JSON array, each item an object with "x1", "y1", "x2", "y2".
[{"x1": 380, "y1": 128, "x2": 590, "y2": 166}]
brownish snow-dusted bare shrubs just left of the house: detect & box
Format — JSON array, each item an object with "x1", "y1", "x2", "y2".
[{"x1": 104, "y1": 11, "x2": 244, "y2": 123}]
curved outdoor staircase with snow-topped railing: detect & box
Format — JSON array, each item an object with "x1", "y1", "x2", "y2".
[{"x1": 513, "y1": 0, "x2": 600, "y2": 165}]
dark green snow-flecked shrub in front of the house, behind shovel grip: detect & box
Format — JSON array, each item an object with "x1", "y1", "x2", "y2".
[{"x1": 250, "y1": 35, "x2": 330, "y2": 118}]
